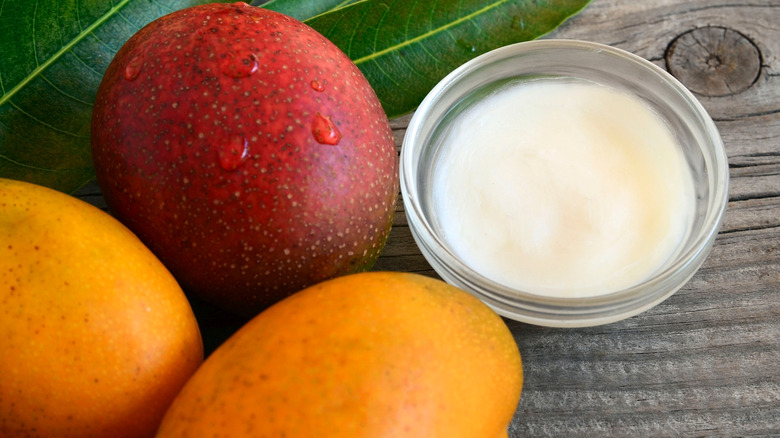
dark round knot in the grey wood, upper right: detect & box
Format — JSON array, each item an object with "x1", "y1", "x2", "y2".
[{"x1": 665, "y1": 26, "x2": 762, "y2": 97}]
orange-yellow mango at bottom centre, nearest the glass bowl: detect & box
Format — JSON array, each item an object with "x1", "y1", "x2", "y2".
[{"x1": 157, "y1": 272, "x2": 523, "y2": 438}]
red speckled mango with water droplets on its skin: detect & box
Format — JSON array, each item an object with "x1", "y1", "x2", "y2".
[{"x1": 92, "y1": 3, "x2": 398, "y2": 315}]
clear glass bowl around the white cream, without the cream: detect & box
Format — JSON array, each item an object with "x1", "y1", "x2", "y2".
[{"x1": 400, "y1": 40, "x2": 728, "y2": 327}]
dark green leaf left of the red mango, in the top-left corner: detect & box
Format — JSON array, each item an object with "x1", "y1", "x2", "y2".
[{"x1": 0, "y1": 0, "x2": 232, "y2": 192}]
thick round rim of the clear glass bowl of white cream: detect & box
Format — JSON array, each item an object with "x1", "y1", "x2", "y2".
[{"x1": 399, "y1": 39, "x2": 729, "y2": 327}]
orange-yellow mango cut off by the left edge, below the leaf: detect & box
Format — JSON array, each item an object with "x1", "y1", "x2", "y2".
[{"x1": 0, "y1": 179, "x2": 203, "y2": 438}]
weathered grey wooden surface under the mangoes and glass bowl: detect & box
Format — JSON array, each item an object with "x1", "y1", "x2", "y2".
[{"x1": 74, "y1": 0, "x2": 780, "y2": 437}]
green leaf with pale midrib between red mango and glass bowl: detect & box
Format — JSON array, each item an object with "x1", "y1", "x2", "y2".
[{"x1": 308, "y1": 0, "x2": 589, "y2": 118}]
